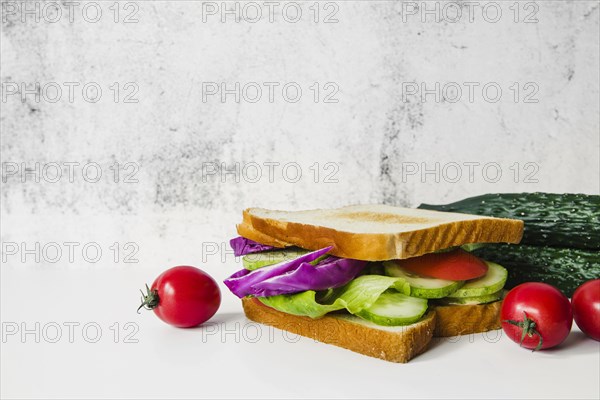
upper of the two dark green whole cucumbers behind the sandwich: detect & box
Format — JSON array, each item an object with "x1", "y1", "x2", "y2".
[{"x1": 419, "y1": 193, "x2": 600, "y2": 248}]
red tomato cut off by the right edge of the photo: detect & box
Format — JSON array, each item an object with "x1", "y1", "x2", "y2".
[{"x1": 571, "y1": 279, "x2": 600, "y2": 341}]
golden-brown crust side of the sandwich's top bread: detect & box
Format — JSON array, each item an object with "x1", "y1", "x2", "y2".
[{"x1": 238, "y1": 208, "x2": 523, "y2": 261}]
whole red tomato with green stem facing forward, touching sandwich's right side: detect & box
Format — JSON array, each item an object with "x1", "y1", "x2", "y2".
[{"x1": 500, "y1": 282, "x2": 573, "y2": 350}]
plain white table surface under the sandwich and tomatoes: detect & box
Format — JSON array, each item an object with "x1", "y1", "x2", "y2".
[{"x1": 1, "y1": 265, "x2": 600, "y2": 399}]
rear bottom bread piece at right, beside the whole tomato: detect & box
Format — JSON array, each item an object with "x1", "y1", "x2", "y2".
[{"x1": 430, "y1": 300, "x2": 502, "y2": 337}]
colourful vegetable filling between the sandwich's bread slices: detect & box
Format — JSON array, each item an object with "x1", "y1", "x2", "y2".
[{"x1": 224, "y1": 237, "x2": 508, "y2": 326}]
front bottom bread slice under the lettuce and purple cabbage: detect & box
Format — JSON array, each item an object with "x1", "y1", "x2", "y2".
[{"x1": 242, "y1": 298, "x2": 436, "y2": 363}]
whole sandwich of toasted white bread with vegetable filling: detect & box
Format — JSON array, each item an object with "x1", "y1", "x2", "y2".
[{"x1": 224, "y1": 205, "x2": 523, "y2": 363}]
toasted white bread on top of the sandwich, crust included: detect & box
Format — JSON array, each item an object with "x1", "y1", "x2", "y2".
[{"x1": 238, "y1": 204, "x2": 523, "y2": 261}]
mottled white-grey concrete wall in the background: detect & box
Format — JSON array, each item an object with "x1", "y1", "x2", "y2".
[{"x1": 1, "y1": 1, "x2": 600, "y2": 268}]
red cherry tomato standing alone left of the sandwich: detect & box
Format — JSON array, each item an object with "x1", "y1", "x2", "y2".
[{"x1": 138, "y1": 266, "x2": 221, "y2": 328}]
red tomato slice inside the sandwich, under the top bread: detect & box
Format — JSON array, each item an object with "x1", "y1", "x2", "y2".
[{"x1": 396, "y1": 249, "x2": 488, "y2": 281}]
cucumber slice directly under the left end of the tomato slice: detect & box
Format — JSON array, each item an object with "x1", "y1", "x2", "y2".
[{"x1": 383, "y1": 261, "x2": 464, "y2": 299}]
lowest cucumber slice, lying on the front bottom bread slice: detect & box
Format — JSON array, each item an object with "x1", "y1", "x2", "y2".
[{"x1": 356, "y1": 292, "x2": 427, "y2": 326}]
